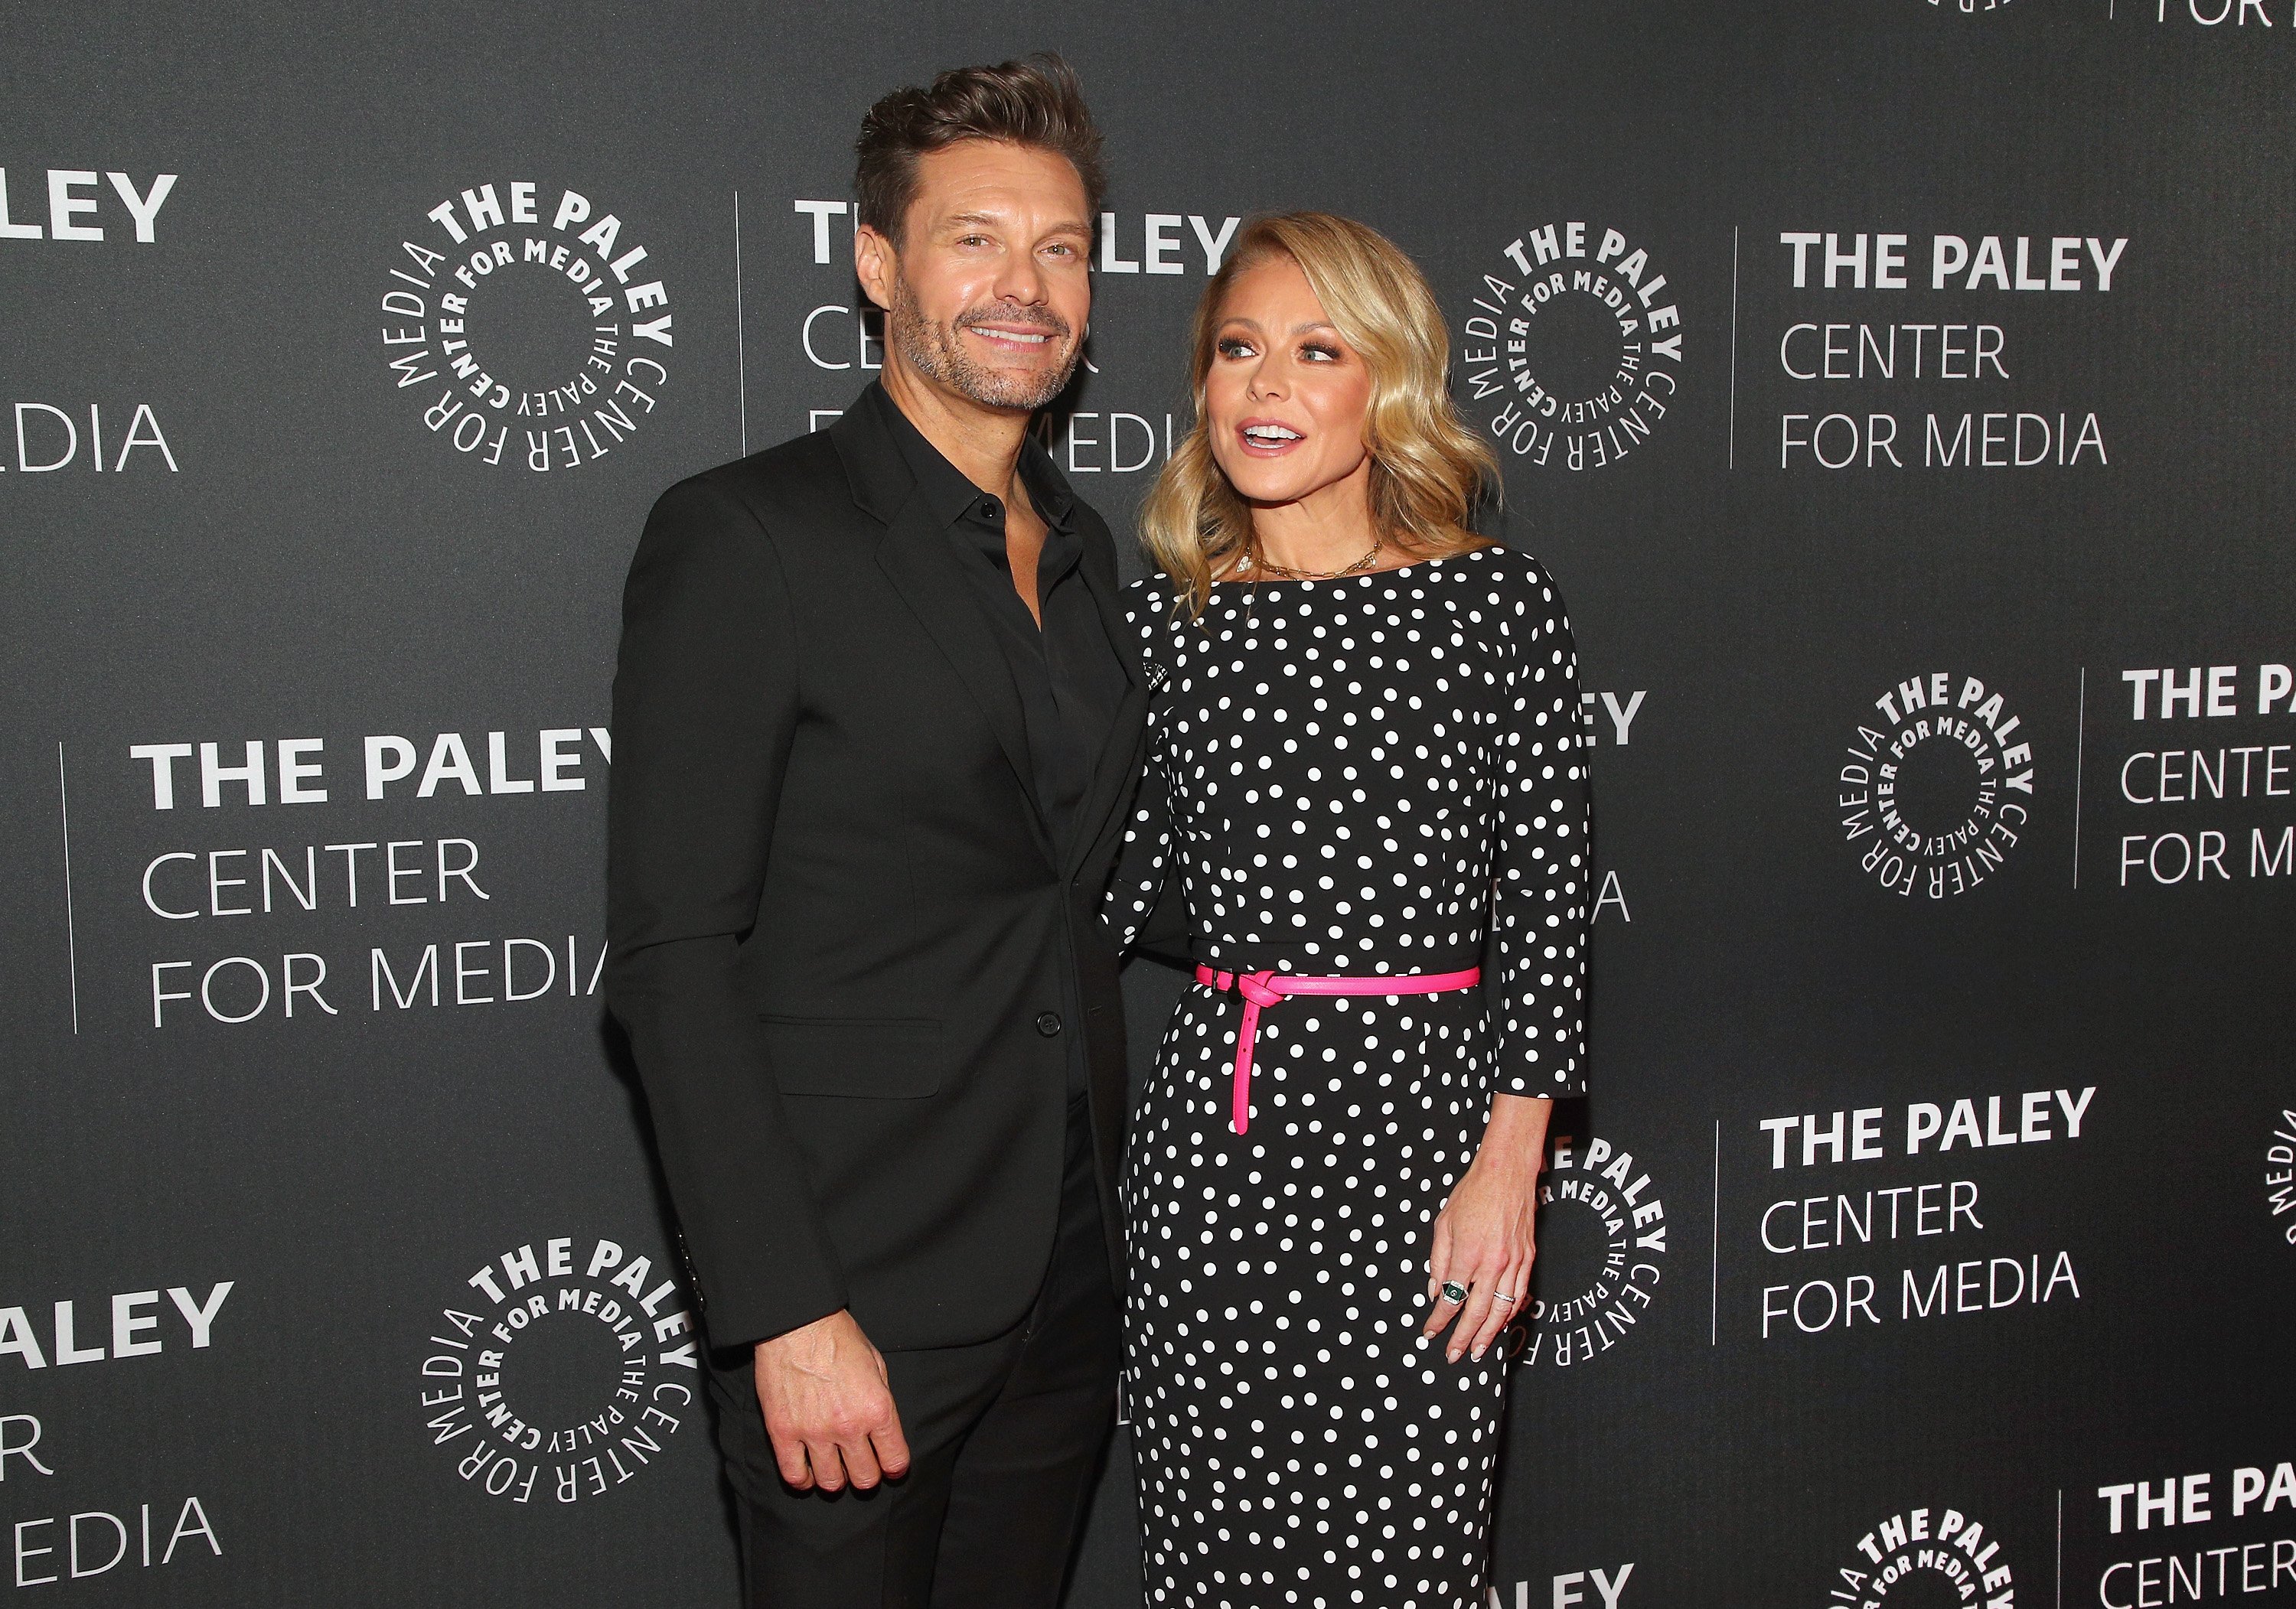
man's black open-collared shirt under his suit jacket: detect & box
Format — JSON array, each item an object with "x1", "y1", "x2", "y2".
[{"x1": 861, "y1": 386, "x2": 1127, "y2": 1095}]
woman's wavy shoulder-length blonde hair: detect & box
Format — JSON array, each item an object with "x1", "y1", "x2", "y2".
[{"x1": 1141, "y1": 211, "x2": 1499, "y2": 620}]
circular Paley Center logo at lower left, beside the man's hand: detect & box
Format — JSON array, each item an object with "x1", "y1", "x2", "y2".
[{"x1": 420, "y1": 1237, "x2": 700, "y2": 1503}]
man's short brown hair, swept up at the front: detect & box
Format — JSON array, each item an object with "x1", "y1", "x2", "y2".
[{"x1": 854, "y1": 50, "x2": 1102, "y2": 246}]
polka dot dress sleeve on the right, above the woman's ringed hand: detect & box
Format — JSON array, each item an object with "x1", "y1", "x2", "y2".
[{"x1": 1486, "y1": 560, "x2": 1593, "y2": 1095}]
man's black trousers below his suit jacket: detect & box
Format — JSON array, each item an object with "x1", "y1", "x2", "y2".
[{"x1": 709, "y1": 1099, "x2": 1123, "y2": 1609}]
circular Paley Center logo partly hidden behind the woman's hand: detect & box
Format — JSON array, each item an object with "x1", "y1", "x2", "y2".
[{"x1": 1506, "y1": 1134, "x2": 1667, "y2": 1368}]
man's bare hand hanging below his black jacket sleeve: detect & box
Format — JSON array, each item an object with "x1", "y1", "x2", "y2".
[{"x1": 755, "y1": 1308, "x2": 909, "y2": 1492}]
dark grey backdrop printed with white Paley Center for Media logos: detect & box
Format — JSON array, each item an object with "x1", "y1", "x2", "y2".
[{"x1": 0, "y1": 0, "x2": 2296, "y2": 1609}]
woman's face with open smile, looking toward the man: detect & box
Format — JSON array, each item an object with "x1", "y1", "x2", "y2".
[{"x1": 1203, "y1": 255, "x2": 1371, "y2": 505}]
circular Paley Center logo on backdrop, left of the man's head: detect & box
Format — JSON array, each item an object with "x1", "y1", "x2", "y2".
[{"x1": 379, "y1": 179, "x2": 675, "y2": 473}]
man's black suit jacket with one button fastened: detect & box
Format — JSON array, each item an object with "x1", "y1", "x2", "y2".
[{"x1": 606, "y1": 395, "x2": 1148, "y2": 1347}]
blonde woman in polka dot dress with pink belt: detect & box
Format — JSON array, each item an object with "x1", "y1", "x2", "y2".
[{"x1": 1109, "y1": 213, "x2": 1589, "y2": 1609}]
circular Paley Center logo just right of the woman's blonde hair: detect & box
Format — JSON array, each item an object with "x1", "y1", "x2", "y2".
[{"x1": 1456, "y1": 220, "x2": 1683, "y2": 471}]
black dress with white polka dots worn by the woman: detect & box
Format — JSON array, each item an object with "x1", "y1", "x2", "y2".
[{"x1": 1109, "y1": 546, "x2": 1591, "y2": 1609}]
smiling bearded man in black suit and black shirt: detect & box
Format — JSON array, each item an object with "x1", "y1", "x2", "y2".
[{"x1": 606, "y1": 57, "x2": 1146, "y2": 1609}]
